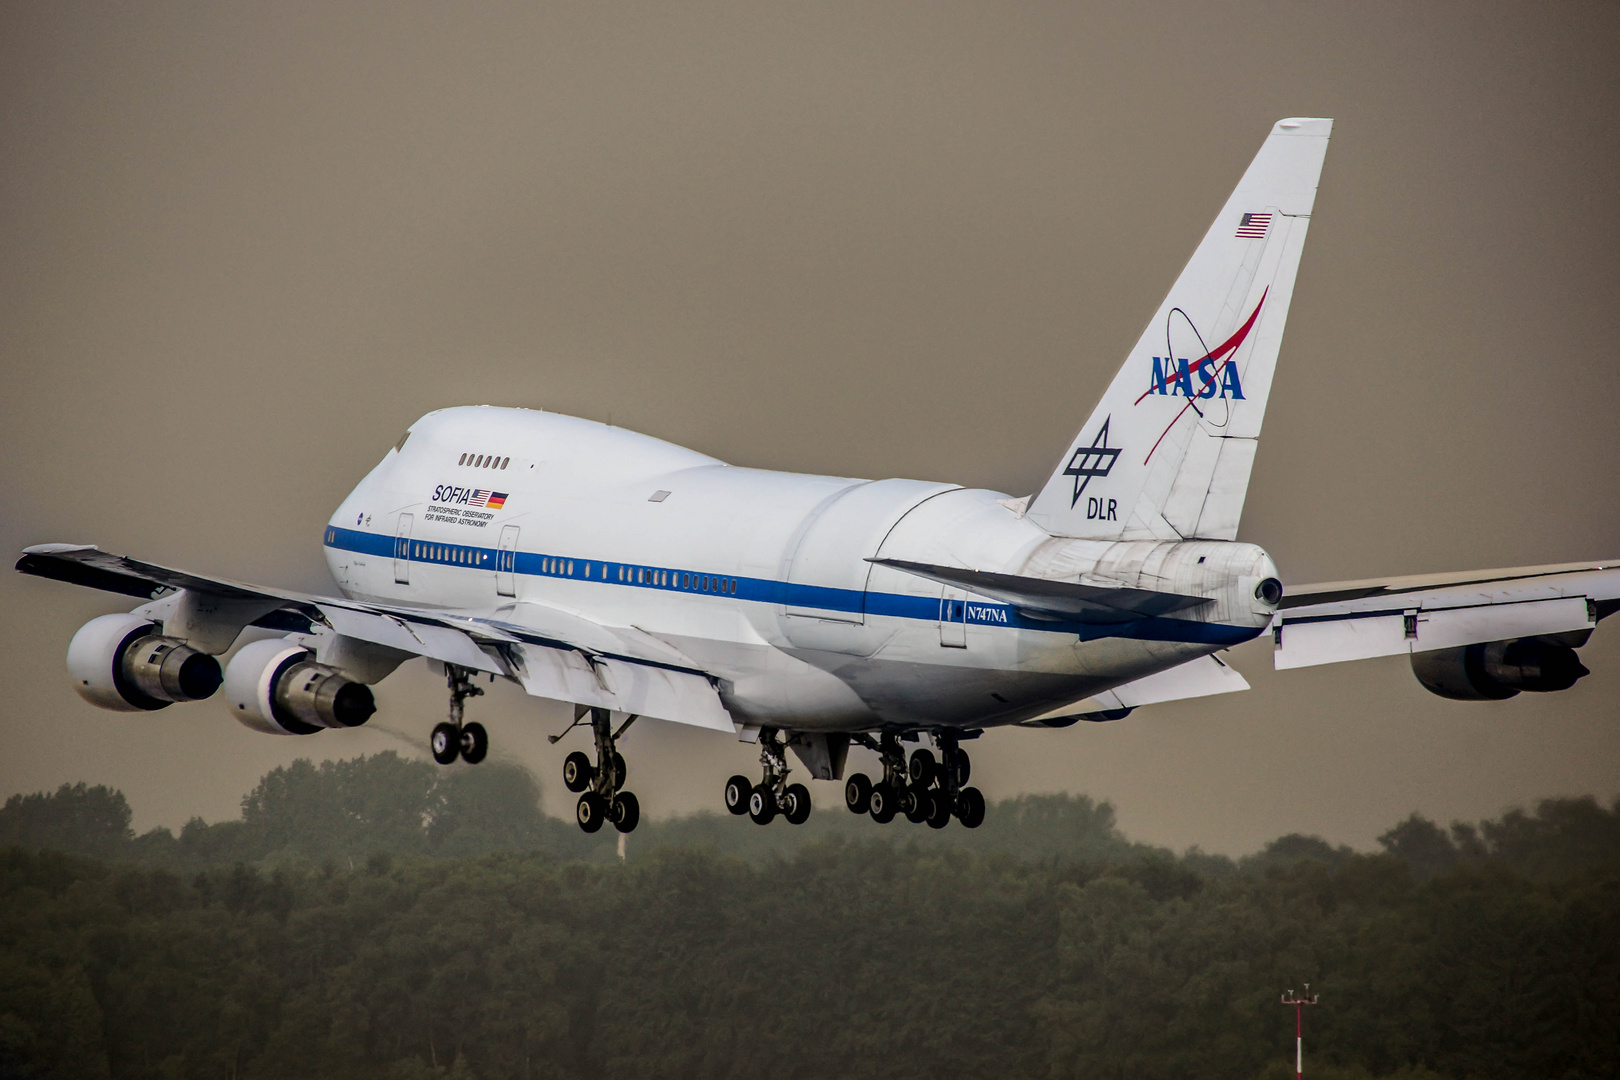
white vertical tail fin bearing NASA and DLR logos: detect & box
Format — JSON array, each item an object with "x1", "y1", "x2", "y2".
[{"x1": 1029, "y1": 118, "x2": 1333, "y2": 541}]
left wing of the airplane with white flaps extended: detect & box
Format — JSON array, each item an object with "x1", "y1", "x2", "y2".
[{"x1": 16, "y1": 544, "x2": 735, "y2": 733}]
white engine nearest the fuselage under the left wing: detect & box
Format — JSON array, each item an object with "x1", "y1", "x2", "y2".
[{"x1": 225, "y1": 638, "x2": 377, "y2": 735}]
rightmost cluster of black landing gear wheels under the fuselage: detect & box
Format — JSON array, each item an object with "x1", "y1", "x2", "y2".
[{"x1": 844, "y1": 732, "x2": 985, "y2": 829}]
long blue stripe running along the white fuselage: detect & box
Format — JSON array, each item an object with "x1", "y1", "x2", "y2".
[{"x1": 326, "y1": 526, "x2": 1264, "y2": 646}]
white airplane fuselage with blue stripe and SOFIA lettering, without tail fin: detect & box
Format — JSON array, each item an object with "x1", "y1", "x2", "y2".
[{"x1": 326, "y1": 406, "x2": 1275, "y2": 730}]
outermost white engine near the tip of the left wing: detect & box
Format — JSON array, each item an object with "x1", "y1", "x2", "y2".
[{"x1": 68, "y1": 615, "x2": 220, "y2": 712}]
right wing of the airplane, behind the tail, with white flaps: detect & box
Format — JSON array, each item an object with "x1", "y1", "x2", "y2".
[{"x1": 1272, "y1": 560, "x2": 1620, "y2": 669}]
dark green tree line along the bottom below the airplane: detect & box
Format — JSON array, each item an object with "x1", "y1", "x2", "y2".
[{"x1": 0, "y1": 755, "x2": 1620, "y2": 1080}]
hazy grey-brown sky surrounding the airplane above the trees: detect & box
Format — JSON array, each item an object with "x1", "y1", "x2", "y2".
[{"x1": 0, "y1": 0, "x2": 1620, "y2": 853}]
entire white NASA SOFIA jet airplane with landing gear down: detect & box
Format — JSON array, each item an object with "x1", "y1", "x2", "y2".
[{"x1": 18, "y1": 120, "x2": 1620, "y2": 832}]
